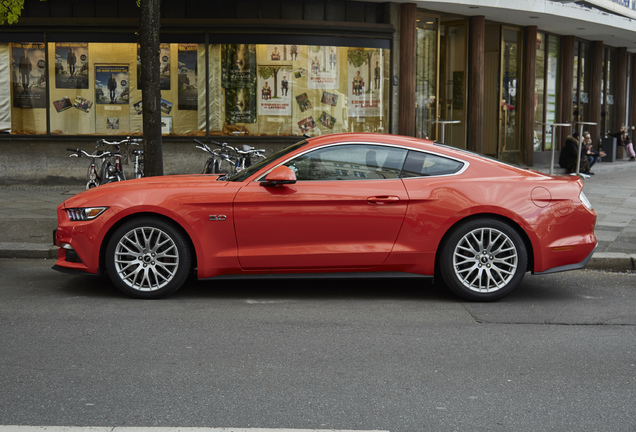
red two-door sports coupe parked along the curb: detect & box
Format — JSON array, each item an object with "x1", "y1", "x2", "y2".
[{"x1": 54, "y1": 134, "x2": 596, "y2": 301}]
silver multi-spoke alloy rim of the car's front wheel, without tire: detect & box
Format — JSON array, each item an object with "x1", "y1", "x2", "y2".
[{"x1": 114, "y1": 226, "x2": 179, "y2": 291}]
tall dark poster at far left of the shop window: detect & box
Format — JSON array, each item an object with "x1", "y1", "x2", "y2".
[{"x1": 11, "y1": 43, "x2": 46, "y2": 108}]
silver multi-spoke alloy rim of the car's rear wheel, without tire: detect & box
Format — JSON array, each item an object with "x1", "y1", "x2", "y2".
[{"x1": 453, "y1": 228, "x2": 519, "y2": 293}]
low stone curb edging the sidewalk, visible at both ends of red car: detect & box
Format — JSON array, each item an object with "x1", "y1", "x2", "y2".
[{"x1": 0, "y1": 242, "x2": 636, "y2": 272}]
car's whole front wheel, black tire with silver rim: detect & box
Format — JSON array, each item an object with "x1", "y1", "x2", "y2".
[{"x1": 105, "y1": 217, "x2": 192, "y2": 299}]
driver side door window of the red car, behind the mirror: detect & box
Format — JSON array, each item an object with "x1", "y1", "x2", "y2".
[{"x1": 285, "y1": 144, "x2": 407, "y2": 181}]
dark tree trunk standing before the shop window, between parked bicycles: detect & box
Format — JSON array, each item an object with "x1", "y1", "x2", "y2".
[{"x1": 138, "y1": 0, "x2": 163, "y2": 176}]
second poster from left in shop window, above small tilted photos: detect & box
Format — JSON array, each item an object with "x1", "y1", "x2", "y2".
[{"x1": 55, "y1": 42, "x2": 88, "y2": 89}]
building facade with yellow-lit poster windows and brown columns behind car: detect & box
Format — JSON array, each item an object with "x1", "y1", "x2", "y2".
[{"x1": 0, "y1": 0, "x2": 636, "y2": 181}]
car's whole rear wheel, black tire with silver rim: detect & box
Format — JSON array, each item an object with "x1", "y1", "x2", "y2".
[{"x1": 439, "y1": 218, "x2": 528, "y2": 301}]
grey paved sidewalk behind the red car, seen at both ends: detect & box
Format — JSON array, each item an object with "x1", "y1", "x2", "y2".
[{"x1": 0, "y1": 160, "x2": 636, "y2": 271}]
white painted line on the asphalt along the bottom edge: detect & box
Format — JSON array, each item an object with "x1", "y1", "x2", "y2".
[{"x1": 0, "y1": 426, "x2": 389, "y2": 432}]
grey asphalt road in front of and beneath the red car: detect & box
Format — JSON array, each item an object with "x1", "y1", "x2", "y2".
[{"x1": 0, "y1": 260, "x2": 636, "y2": 432}]
